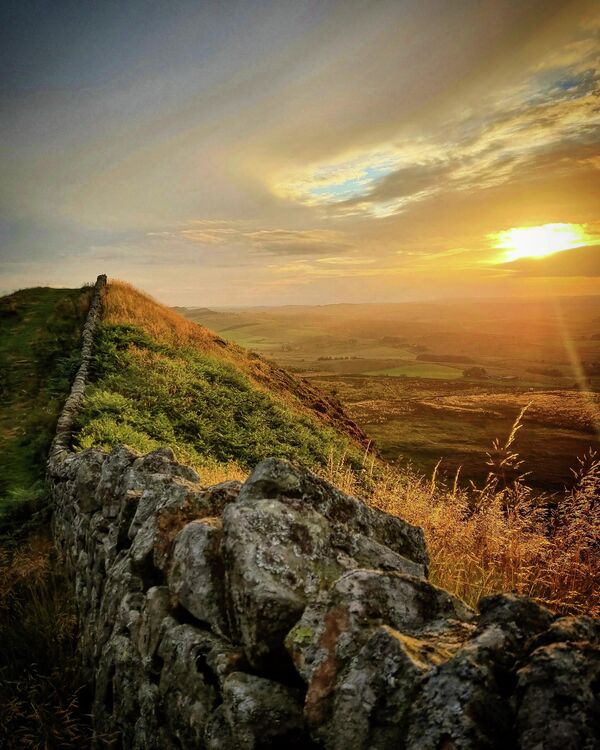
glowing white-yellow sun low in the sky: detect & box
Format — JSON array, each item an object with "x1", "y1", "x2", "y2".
[{"x1": 490, "y1": 224, "x2": 592, "y2": 263}]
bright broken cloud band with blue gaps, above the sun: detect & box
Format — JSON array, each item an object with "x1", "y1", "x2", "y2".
[{"x1": 274, "y1": 22, "x2": 600, "y2": 218}]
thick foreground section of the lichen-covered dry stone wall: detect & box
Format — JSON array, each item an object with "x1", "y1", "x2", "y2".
[{"x1": 48, "y1": 276, "x2": 600, "y2": 750}]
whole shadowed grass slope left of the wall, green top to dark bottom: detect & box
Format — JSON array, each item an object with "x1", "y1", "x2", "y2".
[{"x1": 0, "y1": 288, "x2": 91, "y2": 750}]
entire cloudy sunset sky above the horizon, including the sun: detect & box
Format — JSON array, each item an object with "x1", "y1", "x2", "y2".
[{"x1": 0, "y1": 0, "x2": 600, "y2": 306}]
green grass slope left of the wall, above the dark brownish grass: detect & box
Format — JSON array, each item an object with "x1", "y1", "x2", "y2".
[{"x1": 0, "y1": 288, "x2": 89, "y2": 526}]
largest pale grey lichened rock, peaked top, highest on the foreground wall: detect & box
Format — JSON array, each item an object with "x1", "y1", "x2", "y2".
[{"x1": 223, "y1": 460, "x2": 427, "y2": 667}]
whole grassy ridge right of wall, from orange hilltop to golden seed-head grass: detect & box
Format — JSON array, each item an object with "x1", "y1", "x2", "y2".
[{"x1": 78, "y1": 284, "x2": 600, "y2": 614}]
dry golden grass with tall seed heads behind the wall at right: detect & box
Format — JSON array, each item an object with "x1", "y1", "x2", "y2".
[{"x1": 324, "y1": 440, "x2": 600, "y2": 617}]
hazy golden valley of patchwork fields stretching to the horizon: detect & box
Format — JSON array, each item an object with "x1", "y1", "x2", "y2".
[{"x1": 180, "y1": 297, "x2": 600, "y2": 490}]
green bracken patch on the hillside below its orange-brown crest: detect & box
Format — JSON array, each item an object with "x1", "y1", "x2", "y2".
[{"x1": 76, "y1": 323, "x2": 358, "y2": 476}]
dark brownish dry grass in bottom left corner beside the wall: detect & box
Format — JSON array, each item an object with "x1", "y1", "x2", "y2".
[{"x1": 0, "y1": 533, "x2": 92, "y2": 750}]
